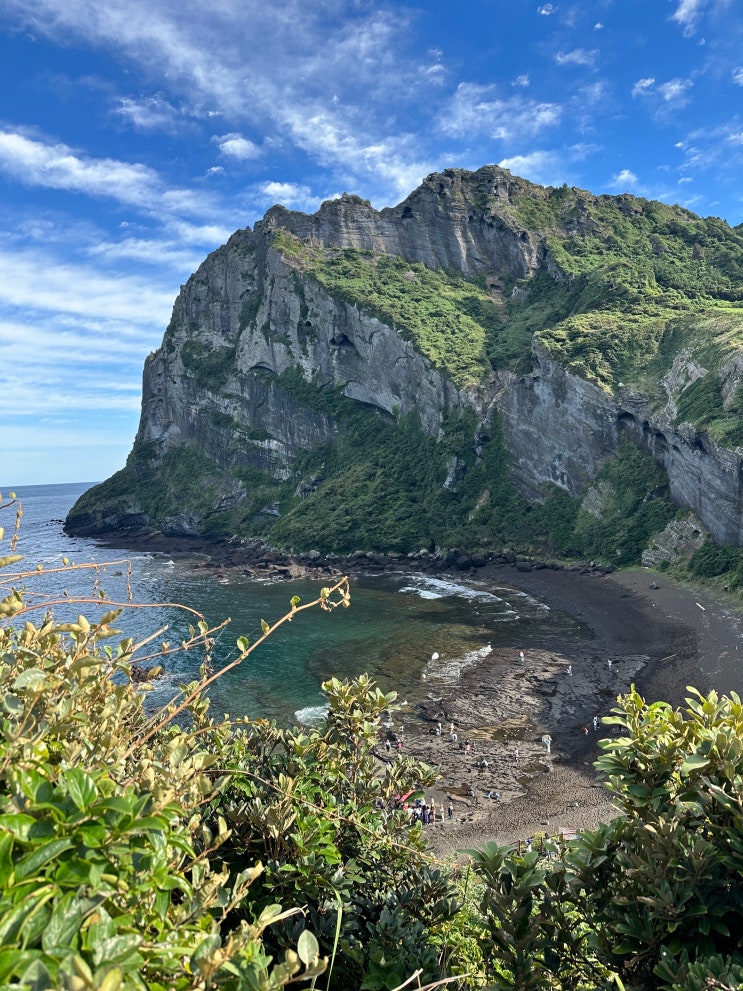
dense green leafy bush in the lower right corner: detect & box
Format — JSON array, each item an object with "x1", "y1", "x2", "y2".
[{"x1": 472, "y1": 689, "x2": 743, "y2": 991}]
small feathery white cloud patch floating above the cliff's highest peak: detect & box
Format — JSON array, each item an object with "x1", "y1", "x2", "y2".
[{"x1": 441, "y1": 83, "x2": 563, "y2": 139}]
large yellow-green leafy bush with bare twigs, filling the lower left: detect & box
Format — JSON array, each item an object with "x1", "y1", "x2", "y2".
[{"x1": 0, "y1": 504, "x2": 464, "y2": 991}]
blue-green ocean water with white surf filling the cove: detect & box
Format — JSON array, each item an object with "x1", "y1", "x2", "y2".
[{"x1": 0, "y1": 483, "x2": 580, "y2": 724}]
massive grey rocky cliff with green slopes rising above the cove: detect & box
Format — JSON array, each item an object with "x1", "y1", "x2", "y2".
[{"x1": 67, "y1": 166, "x2": 743, "y2": 553}]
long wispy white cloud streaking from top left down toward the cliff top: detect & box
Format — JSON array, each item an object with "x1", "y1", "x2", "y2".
[{"x1": 4, "y1": 0, "x2": 430, "y2": 202}]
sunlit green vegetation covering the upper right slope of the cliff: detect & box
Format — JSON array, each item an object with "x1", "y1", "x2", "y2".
[{"x1": 509, "y1": 187, "x2": 743, "y2": 396}]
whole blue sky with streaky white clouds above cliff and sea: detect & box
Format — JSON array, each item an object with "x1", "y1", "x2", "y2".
[{"x1": 0, "y1": 0, "x2": 743, "y2": 489}]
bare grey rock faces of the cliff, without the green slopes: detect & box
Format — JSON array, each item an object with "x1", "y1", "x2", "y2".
[{"x1": 67, "y1": 166, "x2": 743, "y2": 545}]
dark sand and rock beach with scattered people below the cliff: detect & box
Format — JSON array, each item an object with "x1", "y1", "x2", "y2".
[{"x1": 396, "y1": 566, "x2": 743, "y2": 858}]
